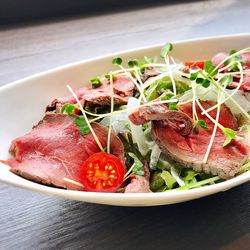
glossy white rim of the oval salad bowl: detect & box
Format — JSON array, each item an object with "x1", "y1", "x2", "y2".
[{"x1": 0, "y1": 33, "x2": 250, "y2": 204}]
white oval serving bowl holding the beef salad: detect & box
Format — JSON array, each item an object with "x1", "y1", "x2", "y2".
[{"x1": 0, "y1": 34, "x2": 250, "y2": 206}]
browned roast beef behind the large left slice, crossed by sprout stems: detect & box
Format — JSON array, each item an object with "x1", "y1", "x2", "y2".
[{"x1": 46, "y1": 75, "x2": 134, "y2": 111}]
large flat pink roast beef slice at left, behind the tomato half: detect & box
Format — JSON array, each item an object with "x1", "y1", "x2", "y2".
[{"x1": 3, "y1": 114, "x2": 124, "y2": 189}]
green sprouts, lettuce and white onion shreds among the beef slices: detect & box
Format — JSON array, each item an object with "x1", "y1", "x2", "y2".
[{"x1": 61, "y1": 43, "x2": 250, "y2": 192}]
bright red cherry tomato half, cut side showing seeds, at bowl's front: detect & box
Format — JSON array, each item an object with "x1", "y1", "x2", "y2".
[{"x1": 82, "y1": 152, "x2": 125, "y2": 193}]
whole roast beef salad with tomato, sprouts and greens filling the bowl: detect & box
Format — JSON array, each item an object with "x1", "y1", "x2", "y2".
[{"x1": 2, "y1": 43, "x2": 250, "y2": 193}]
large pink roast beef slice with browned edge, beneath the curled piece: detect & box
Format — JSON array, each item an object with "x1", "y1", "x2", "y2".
[{"x1": 152, "y1": 101, "x2": 249, "y2": 179}]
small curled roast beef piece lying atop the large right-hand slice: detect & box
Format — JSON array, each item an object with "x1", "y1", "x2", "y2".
[{"x1": 129, "y1": 105, "x2": 193, "y2": 136}]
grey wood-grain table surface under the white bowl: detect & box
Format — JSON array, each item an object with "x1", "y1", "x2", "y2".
[{"x1": 0, "y1": 0, "x2": 250, "y2": 250}]
